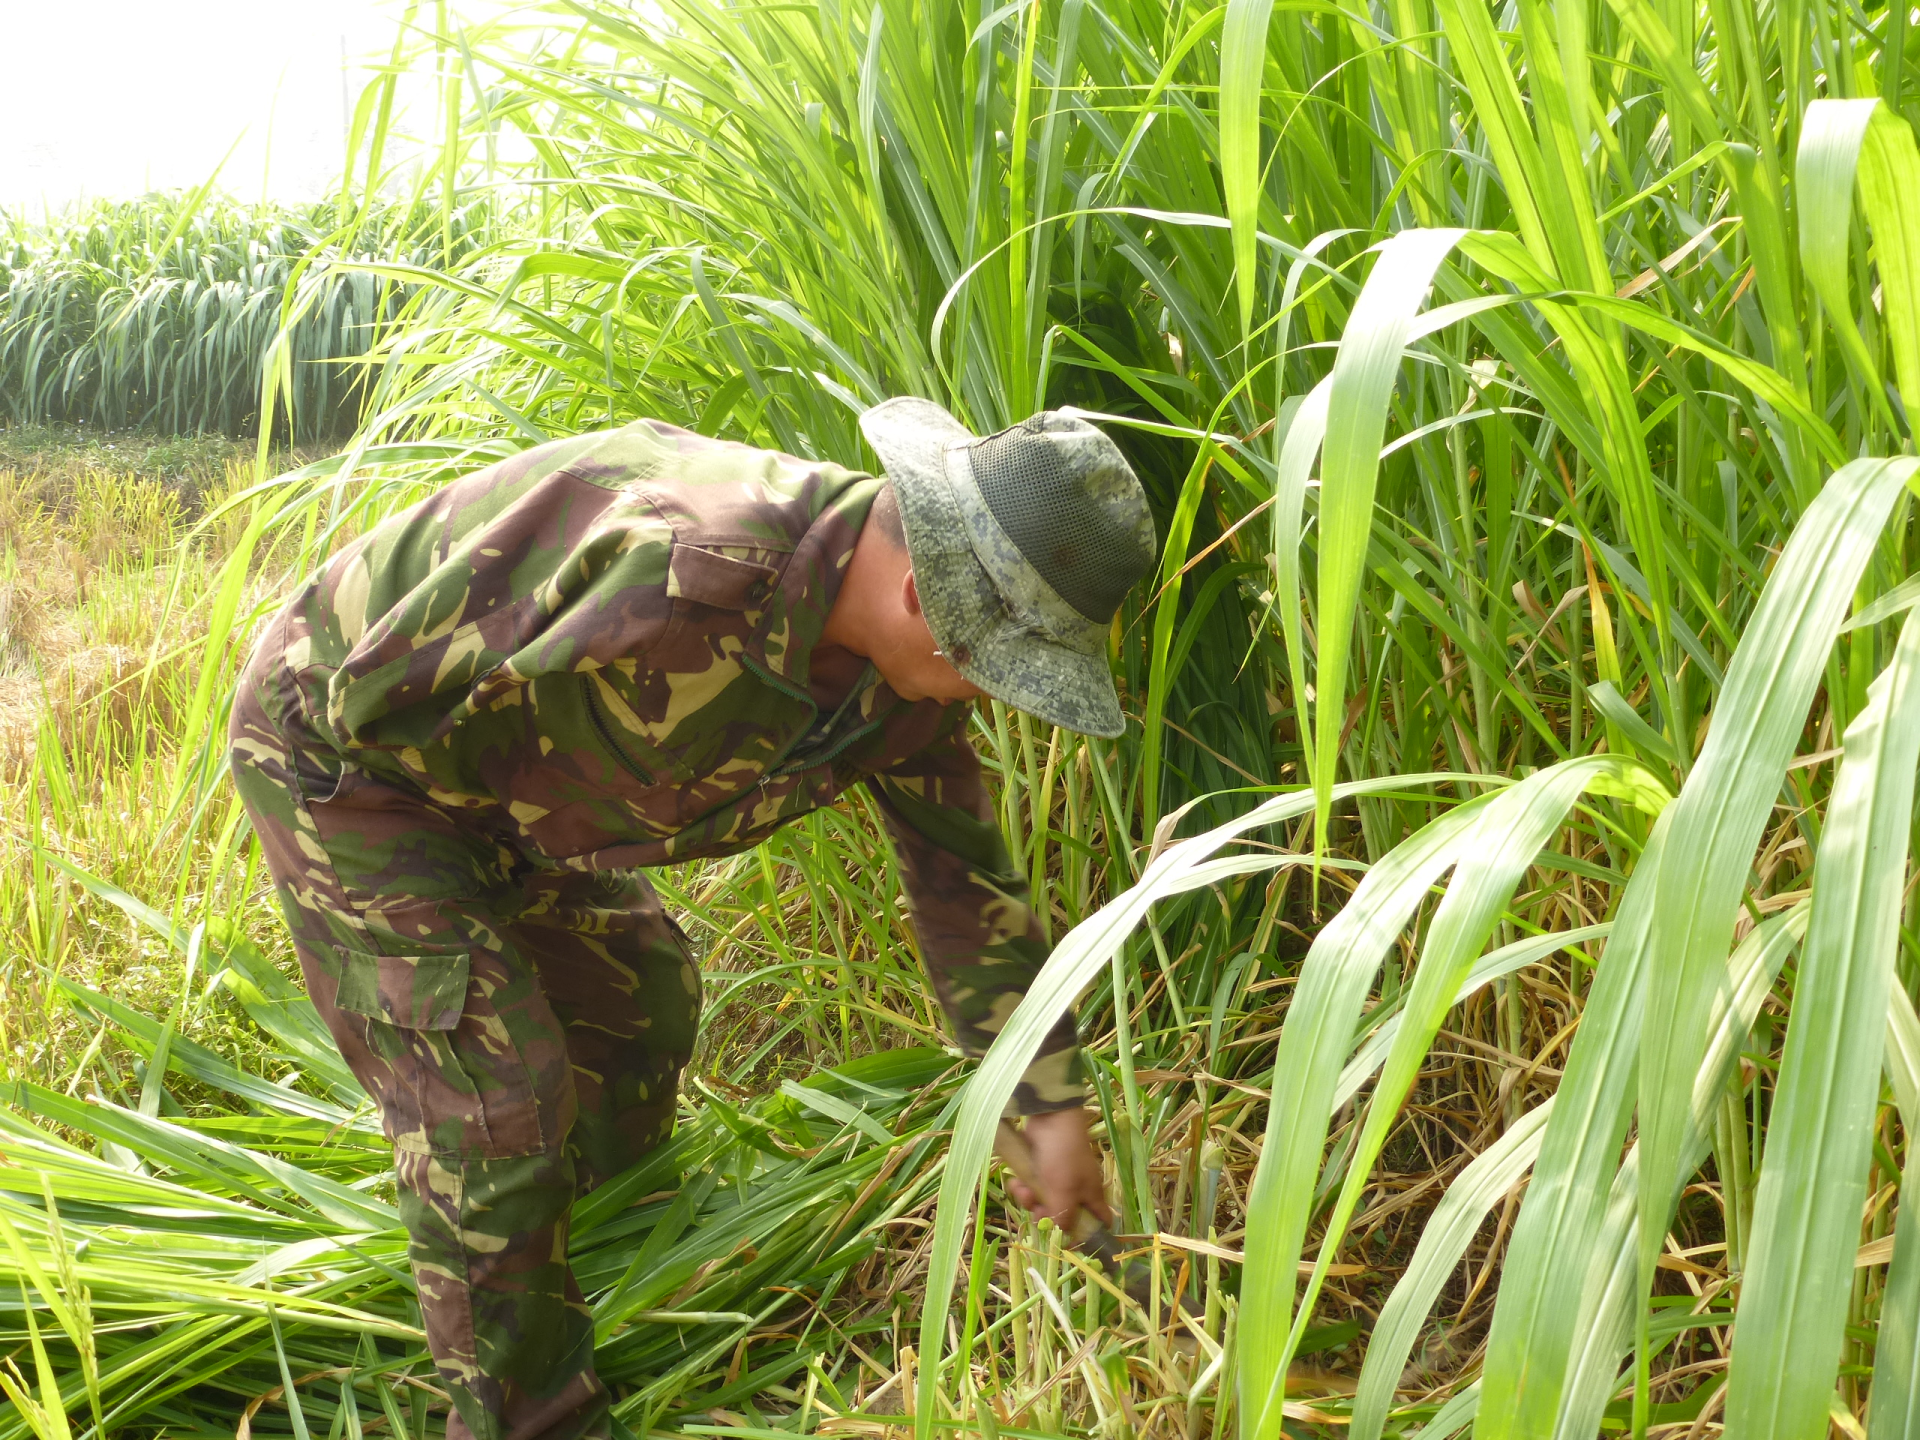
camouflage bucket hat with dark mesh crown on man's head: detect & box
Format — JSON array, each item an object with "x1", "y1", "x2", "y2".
[{"x1": 860, "y1": 396, "x2": 1158, "y2": 737}]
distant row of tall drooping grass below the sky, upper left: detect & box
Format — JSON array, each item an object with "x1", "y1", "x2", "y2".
[{"x1": 0, "y1": 190, "x2": 484, "y2": 444}]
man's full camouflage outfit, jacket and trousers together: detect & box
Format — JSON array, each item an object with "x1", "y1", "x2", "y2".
[{"x1": 230, "y1": 420, "x2": 1083, "y2": 1440}]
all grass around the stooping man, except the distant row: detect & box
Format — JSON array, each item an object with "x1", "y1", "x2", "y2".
[{"x1": 0, "y1": 0, "x2": 1920, "y2": 1440}]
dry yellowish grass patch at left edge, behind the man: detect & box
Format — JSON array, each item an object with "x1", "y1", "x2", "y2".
[{"x1": 0, "y1": 428, "x2": 316, "y2": 1092}]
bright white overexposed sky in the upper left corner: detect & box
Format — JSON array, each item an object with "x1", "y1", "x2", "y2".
[{"x1": 0, "y1": 0, "x2": 408, "y2": 215}]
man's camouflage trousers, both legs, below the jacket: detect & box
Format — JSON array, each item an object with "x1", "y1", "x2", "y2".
[{"x1": 230, "y1": 614, "x2": 699, "y2": 1440}]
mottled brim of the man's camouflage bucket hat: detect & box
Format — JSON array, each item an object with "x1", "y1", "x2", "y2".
[{"x1": 860, "y1": 396, "x2": 1127, "y2": 739}]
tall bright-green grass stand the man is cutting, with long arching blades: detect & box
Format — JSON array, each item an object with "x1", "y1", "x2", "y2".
[{"x1": 0, "y1": 0, "x2": 1920, "y2": 1440}]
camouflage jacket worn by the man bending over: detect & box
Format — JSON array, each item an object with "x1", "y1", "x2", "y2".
[{"x1": 276, "y1": 420, "x2": 1083, "y2": 1114}]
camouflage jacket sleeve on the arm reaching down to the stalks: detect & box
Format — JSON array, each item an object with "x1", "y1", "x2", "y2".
[{"x1": 866, "y1": 710, "x2": 1085, "y2": 1116}]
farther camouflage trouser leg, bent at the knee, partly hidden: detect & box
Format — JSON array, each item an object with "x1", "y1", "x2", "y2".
[{"x1": 507, "y1": 872, "x2": 701, "y2": 1192}]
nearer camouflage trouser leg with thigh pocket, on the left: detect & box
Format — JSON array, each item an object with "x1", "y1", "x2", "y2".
[{"x1": 232, "y1": 636, "x2": 607, "y2": 1440}]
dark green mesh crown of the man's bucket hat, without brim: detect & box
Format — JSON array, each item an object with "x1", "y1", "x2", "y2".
[{"x1": 972, "y1": 417, "x2": 1154, "y2": 622}]
